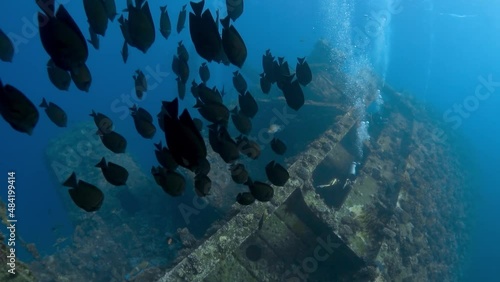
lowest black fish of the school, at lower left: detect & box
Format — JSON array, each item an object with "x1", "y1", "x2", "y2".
[{"x1": 63, "y1": 172, "x2": 104, "y2": 212}]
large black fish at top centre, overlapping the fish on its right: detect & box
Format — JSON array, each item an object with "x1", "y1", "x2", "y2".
[{"x1": 189, "y1": 0, "x2": 223, "y2": 62}]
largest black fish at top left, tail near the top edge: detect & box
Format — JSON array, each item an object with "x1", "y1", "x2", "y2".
[{"x1": 37, "y1": 0, "x2": 88, "y2": 71}]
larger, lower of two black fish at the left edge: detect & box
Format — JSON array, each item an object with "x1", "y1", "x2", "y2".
[{"x1": 0, "y1": 81, "x2": 39, "y2": 135}]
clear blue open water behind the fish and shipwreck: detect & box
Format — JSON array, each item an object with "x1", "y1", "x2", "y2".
[{"x1": 0, "y1": 0, "x2": 500, "y2": 281}]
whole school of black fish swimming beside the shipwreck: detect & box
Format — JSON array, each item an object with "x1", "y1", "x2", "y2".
[{"x1": 0, "y1": 0, "x2": 312, "y2": 212}]
